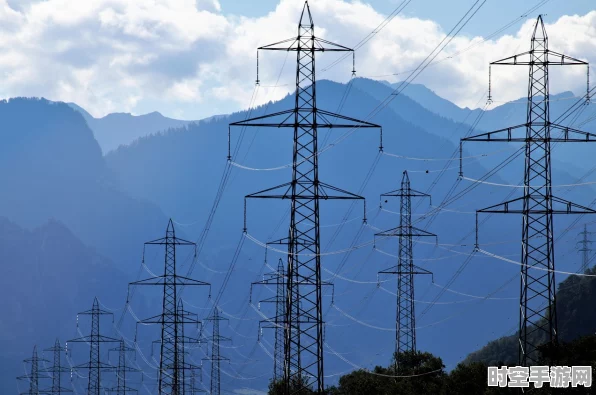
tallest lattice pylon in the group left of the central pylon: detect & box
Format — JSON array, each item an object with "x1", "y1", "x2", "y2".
[{"x1": 129, "y1": 219, "x2": 210, "y2": 395}]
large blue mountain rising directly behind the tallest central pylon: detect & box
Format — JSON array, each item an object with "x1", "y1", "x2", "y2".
[{"x1": 105, "y1": 79, "x2": 593, "y2": 390}]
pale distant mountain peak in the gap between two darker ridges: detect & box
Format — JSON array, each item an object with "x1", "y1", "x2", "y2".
[{"x1": 69, "y1": 103, "x2": 198, "y2": 153}]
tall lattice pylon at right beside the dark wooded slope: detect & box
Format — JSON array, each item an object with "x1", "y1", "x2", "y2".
[{"x1": 460, "y1": 16, "x2": 596, "y2": 366}]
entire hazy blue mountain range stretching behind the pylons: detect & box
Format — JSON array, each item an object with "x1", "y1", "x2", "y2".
[{"x1": 0, "y1": 79, "x2": 594, "y2": 393}]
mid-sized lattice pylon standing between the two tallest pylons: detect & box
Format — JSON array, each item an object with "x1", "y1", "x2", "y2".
[{"x1": 375, "y1": 171, "x2": 436, "y2": 372}]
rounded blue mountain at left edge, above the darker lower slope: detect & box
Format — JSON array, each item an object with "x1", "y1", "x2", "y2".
[{"x1": 0, "y1": 98, "x2": 167, "y2": 273}]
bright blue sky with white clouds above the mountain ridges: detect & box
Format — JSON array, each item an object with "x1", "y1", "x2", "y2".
[{"x1": 0, "y1": 0, "x2": 596, "y2": 119}]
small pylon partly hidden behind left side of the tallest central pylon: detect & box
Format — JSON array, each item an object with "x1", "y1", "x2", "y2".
[{"x1": 251, "y1": 258, "x2": 286, "y2": 382}]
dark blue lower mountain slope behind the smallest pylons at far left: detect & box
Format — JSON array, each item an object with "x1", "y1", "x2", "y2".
[{"x1": 0, "y1": 217, "x2": 128, "y2": 394}]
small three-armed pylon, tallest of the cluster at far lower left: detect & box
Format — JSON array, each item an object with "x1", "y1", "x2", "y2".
[{"x1": 67, "y1": 297, "x2": 119, "y2": 395}]
